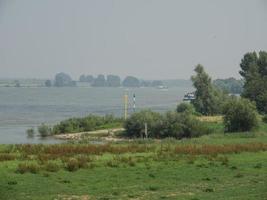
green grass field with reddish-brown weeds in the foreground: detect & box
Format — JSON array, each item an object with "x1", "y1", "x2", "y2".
[{"x1": 0, "y1": 122, "x2": 267, "y2": 200}]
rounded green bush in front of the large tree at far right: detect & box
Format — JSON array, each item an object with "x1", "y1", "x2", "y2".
[{"x1": 223, "y1": 98, "x2": 258, "y2": 132}]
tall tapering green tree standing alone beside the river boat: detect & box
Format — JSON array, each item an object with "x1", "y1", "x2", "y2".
[{"x1": 191, "y1": 64, "x2": 224, "y2": 115}]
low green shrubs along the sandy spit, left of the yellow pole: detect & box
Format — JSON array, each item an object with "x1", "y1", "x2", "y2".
[{"x1": 52, "y1": 115, "x2": 122, "y2": 134}]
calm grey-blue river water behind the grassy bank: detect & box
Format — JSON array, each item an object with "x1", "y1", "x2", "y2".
[{"x1": 0, "y1": 87, "x2": 192, "y2": 144}]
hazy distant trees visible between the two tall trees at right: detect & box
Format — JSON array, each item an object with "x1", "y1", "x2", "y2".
[{"x1": 213, "y1": 78, "x2": 244, "y2": 94}]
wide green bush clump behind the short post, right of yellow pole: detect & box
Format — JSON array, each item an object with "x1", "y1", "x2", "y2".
[{"x1": 124, "y1": 110, "x2": 210, "y2": 139}]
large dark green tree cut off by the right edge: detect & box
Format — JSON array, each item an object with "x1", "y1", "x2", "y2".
[{"x1": 240, "y1": 51, "x2": 267, "y2": 113}]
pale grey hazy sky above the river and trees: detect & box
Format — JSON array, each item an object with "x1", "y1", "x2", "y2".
[{"x1": 0, "y1": 0, "x2": 267, "y2": 79}]
